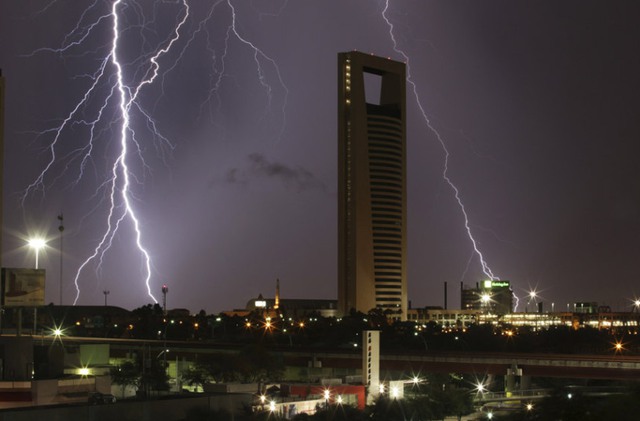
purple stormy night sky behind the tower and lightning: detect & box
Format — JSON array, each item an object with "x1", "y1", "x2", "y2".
[{"x1": 0, "y1": 0, "x2": 640, "y2": 313}]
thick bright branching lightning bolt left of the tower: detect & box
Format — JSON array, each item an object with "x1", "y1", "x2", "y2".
[{"x1": 21, "y1": 0, "x2": 289, "y2": 305}]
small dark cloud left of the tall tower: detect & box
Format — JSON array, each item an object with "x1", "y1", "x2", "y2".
[{"x1": 225, "y1": 153, "x2": 326, "y2": 192}]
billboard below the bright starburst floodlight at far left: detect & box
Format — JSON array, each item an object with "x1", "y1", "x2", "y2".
[{"x1": 2, "y1": 268, "x2": 46, "y2": 307}]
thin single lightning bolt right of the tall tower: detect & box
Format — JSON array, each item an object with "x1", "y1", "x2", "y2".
[{"x1": 382, "y1": 0, "x2": 498, "y2": 280}]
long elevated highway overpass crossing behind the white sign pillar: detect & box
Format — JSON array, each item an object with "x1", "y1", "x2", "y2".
[{"x1": 34, "y1": 337, "x2": 640, "y2": 380}]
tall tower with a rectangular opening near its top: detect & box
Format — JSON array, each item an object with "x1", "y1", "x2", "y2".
[{"x1": 338, "y1": 52, "x2": 407, "y2": 320}]
